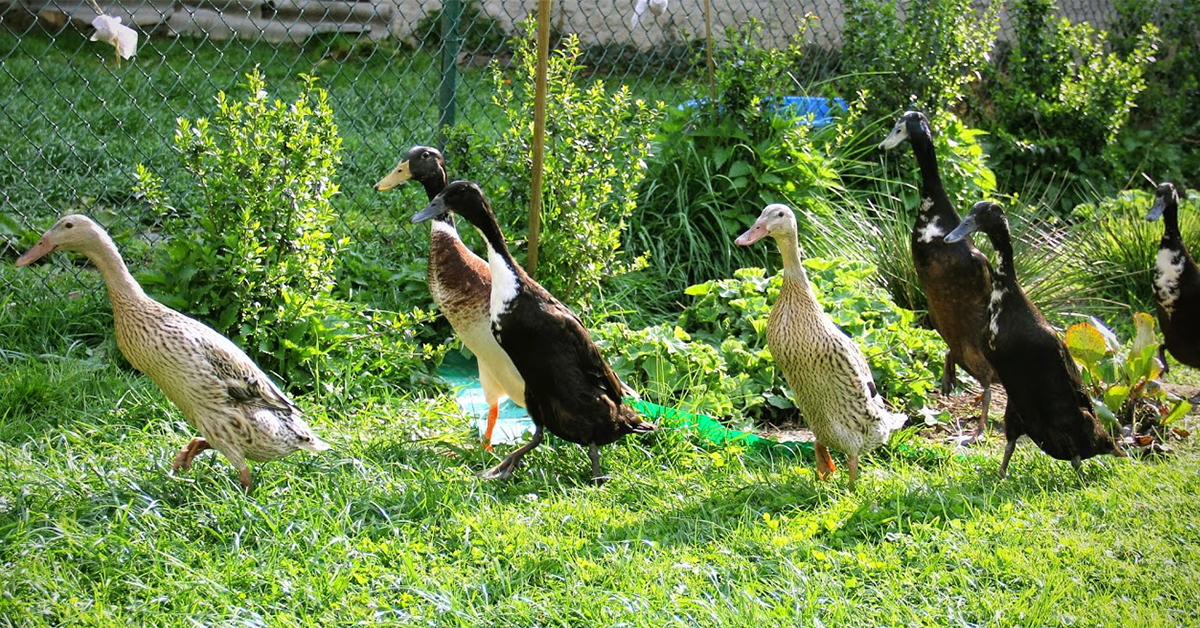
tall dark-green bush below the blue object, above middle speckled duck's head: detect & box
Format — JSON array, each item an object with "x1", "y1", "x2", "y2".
[{"x1": 626, "y1": 20, "x2": 878, "y2": 312}]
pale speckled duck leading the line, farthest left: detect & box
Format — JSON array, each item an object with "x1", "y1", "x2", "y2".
[{"x1": 17, "y1": 214, "x2": 330, "y2": 492}]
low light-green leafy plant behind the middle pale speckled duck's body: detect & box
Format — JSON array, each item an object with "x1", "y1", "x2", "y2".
[{"x1": 596, "y1": 258, "x2": 944, "y2": 423}]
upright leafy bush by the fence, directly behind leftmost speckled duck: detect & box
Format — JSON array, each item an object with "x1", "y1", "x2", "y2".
[{"x1": 136, "y1": 70, "x2": 446, "y2": 385}]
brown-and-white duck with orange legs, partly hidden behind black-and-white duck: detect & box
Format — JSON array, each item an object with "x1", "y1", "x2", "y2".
[{"x1": 374, "y1": 145, "x2": 524, "y2": 451}]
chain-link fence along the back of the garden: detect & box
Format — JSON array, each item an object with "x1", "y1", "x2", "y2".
[{"x1": 0, "y1": 0, "x2": 1114, "y2": 302}]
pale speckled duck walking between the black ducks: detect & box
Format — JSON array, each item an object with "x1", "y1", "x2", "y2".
[{"x1": 734, "y1": 203, "x2": 908, "y2": 490}]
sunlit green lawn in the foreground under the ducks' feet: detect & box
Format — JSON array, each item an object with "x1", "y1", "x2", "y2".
[{"x1": 0, "y1": 348, "x2": 1200, "y2": 627}]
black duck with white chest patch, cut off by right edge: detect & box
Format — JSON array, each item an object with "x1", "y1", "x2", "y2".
[{"x1": 1146, "y1": 181, "x2": 1200, "y2": 373}]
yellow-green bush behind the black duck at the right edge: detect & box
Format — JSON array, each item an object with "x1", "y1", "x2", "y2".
[{"x1": 1068, "y1": 190, "x2": 1200, "y2": 311}]
